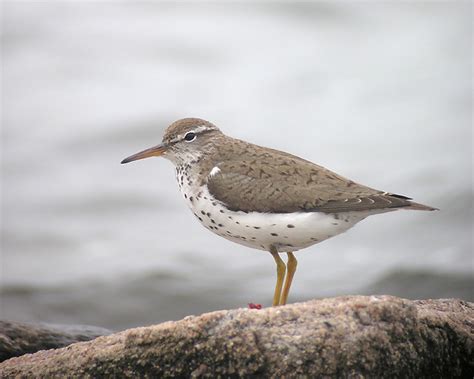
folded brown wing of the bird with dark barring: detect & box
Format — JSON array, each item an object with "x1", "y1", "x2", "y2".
[{"x1": 207, "y1": 154, "x2": 428, "y2": 213}]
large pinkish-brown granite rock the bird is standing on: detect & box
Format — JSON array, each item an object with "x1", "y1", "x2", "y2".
[{"x1": 0, "y1": 296, "x2": 474, "y2": 378}]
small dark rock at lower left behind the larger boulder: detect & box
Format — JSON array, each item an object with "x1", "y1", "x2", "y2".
[{"x1": 0, "y1": 321, "x2": 112, "y2": 362}]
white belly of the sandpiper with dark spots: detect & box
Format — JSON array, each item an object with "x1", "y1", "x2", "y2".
[{"x1": 180, "y1": 185, "x2": 374, "y2": 252}]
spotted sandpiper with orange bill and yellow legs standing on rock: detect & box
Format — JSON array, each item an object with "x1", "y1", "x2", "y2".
[{"x1": 122, "y1": 118, "x2": 436, "y2": 305}]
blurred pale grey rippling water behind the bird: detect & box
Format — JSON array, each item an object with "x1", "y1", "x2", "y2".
[{"x1": 1, "y1": 2, "x2": 474, "y2": 329}]
